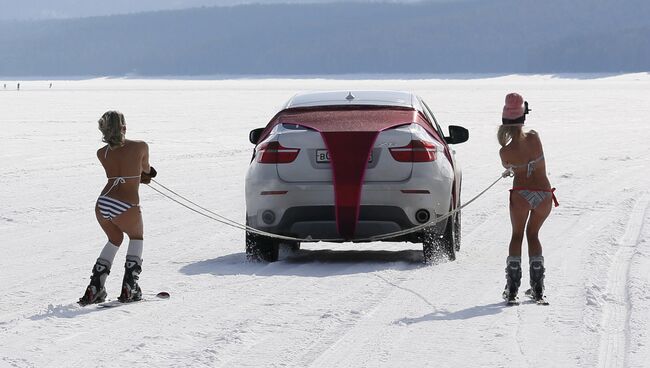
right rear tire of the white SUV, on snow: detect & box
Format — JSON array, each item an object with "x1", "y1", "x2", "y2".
[{"x1": 422, "y1": 206, "x2": 460, "y2": 264}]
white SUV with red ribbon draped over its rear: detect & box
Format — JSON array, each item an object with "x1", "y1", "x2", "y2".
[{"x1": 246, "y1": 91, "x2": 469, "y2": 262}]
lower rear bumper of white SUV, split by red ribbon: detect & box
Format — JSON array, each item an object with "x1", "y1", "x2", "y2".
[{"x1": 246, "y1": 167, "x2": 453, "y2": 242}]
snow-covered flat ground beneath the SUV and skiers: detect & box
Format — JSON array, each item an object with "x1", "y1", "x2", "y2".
[{"x1": 0, "y1": 74, "x2": 650, "y2": 367}]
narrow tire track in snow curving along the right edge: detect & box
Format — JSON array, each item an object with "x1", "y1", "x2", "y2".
[{"x1": 598, "y1": 194, "x2": 650, "y2": 368}]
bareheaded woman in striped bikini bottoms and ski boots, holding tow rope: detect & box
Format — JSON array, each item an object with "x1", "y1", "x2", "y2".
[{"x1": 79, "y1": 111, "x2": 156, "y2": 305}]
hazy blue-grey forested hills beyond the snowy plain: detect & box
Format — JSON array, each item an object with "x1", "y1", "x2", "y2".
[{"x1": 0, "y1": 0, "x2": 650, "y2": 76}]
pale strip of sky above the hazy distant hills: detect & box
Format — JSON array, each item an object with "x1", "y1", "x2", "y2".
[{"x1": 0, "y1": 0, "x2": 468, "y2": 20}]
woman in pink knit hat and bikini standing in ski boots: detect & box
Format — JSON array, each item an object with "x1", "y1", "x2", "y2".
[{"x1": 497, "y1": 93, "x2": 557, "y2": 302}]
